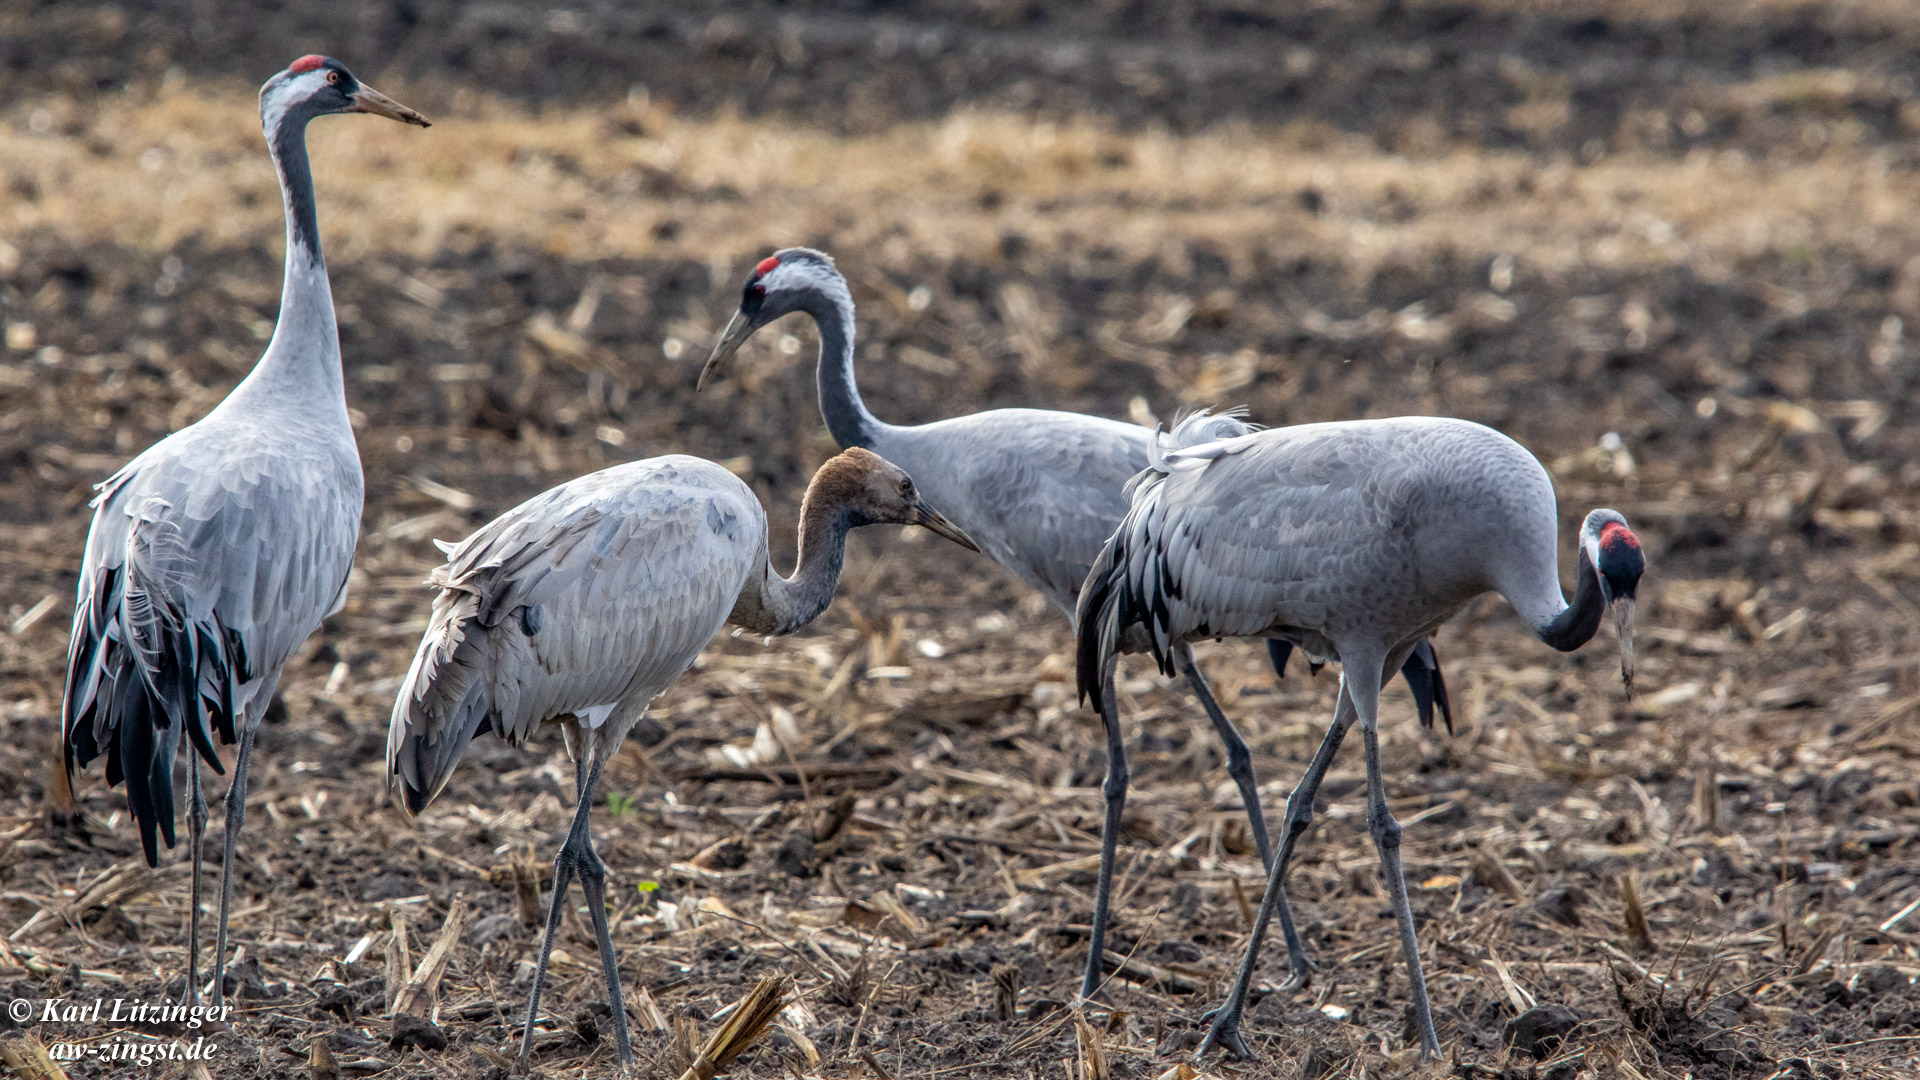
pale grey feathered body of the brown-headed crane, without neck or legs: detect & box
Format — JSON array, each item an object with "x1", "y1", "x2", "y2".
[{"x1": 388, "y1": 457, "x2": 766, "y2": 813}]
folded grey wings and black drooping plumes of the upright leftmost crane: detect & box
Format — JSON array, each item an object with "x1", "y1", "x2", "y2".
[{"x1": 61, "y1": 429, "x2": 361, "y2": 863}]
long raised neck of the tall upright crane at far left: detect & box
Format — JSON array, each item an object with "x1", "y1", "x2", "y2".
[{"x1": 234, "y1": 108, "x2": 348, "y2": 413}]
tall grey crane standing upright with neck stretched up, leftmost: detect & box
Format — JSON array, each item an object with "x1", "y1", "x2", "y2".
[{"x1": 61, "y1": 56, "x2": 426, "y2": 1003}]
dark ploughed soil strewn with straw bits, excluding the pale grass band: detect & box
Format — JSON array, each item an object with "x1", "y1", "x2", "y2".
[{"x1": 0, "y1": 0, "x2": 1920, "y2": 1080}]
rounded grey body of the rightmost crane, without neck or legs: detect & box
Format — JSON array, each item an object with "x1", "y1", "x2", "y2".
[{"x1": 1116, "y1": 417, "x2": 1565, "y2": 671}]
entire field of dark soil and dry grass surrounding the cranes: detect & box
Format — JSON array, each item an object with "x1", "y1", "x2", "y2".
[{"x1": 0, "y1": 0, "x2": 1920, "y2": 1080}]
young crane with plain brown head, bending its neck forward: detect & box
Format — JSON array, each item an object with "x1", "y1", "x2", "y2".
[{"x1": 386, "y1": 450, "x2": 973, "y2": 1065}]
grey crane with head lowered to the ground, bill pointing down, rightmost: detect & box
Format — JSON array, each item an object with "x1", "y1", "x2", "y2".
[{"x1": 1077, "y1": 417, "x2": 1645, "y2": 1057}]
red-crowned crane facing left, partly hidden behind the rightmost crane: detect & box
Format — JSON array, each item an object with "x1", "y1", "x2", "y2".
[{"x1": 699, "y1": 248, "x2": 1453, "y2": 997}]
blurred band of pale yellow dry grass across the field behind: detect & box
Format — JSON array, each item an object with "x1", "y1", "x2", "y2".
[{"x1": 11, "y1": 71, "x2": 1920, "y2": 281}]
